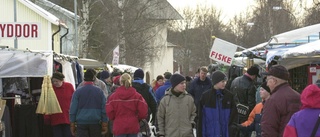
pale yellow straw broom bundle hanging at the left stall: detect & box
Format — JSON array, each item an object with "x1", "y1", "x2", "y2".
[{"x1": 36, "y1": 75, "x2": 62, "y2": 115}]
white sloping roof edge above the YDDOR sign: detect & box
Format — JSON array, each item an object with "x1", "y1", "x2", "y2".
[{"x1": 19, "y1": 0, "x2": 60, "y2": 26}]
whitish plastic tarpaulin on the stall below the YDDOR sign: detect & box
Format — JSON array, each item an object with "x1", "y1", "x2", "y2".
[{"x1": 0, "y1": 49, "x2": 53, "y2": 78}]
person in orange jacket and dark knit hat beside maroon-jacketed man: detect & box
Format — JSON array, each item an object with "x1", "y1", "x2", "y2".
[{"x1": 239, "y1": 82, "x2": 271, "y2": 137}]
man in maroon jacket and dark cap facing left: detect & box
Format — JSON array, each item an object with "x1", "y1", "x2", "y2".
[{"x1": 261, "y1": 65, "x2": 301, "y2": 137}]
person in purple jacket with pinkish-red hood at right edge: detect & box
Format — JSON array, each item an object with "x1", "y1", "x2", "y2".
[{"x1": 283, "y1": 84, "x2": 320, "y2": 137}]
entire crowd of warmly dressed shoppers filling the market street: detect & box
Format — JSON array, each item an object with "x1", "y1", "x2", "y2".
[{"x1": 45, "y1": 65, "x2": 320, "y2": 137}]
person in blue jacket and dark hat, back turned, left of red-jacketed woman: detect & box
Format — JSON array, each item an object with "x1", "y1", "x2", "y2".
[{"x1": 69, "y1": 71, "x2": 108, "y2": 137}]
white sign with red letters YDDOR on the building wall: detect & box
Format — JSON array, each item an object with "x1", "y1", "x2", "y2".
[{"x1": 0, "y1": 23, "x2": 40, "y2": 39}]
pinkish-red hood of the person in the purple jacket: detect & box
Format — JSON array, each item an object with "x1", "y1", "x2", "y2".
[{"x1": 300, "y1": 84, "x2": 320, "y2": 109}]
